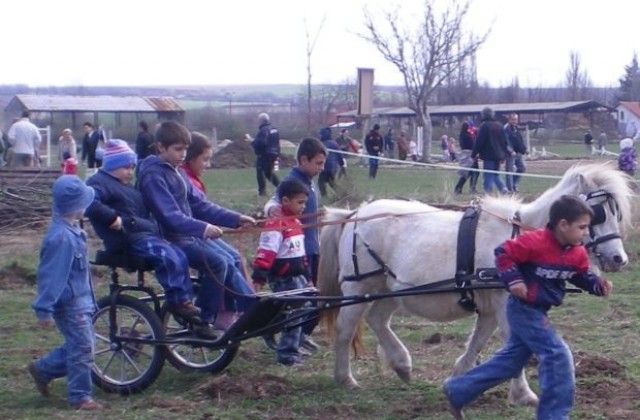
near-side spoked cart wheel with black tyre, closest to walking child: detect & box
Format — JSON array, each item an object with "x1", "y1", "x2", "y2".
[{"x1": 91, "y1": 295, "x2": 164, "y2": 395}]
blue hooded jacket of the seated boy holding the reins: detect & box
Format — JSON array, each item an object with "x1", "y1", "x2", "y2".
[{"x1": 137, "y1": 155, "x2": 241, "y2": 243}]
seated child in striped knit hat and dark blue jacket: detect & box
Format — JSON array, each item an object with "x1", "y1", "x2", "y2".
[{"x1": 85, "y1": 139, "x2": 200, "y2": 322}]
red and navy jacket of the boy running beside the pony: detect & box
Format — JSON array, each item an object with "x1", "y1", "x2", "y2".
[{"x1": 494, "y1": 228, "x2": 603, "y2": 309}]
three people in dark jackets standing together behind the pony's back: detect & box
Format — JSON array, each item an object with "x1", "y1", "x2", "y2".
[{"x1": 454, "y1": 107, "x2": 527, "y2": 194}]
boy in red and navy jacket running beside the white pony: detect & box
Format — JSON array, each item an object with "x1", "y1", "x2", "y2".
[{"x1": 444, "y1": 195, "x2": 612, "y2": 419}]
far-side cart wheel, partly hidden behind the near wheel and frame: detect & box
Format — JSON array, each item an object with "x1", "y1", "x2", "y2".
[{"x1": 162, "y1": 302, "x2": 238, "y2": 373}]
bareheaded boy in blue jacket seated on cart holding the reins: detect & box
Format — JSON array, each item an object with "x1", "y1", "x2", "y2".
[{"x1": 138, "y1": 121, "x2": 255, "y2": 330}]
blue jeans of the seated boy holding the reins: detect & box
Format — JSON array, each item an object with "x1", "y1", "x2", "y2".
[{"x1": 178, "y1": 239, "x2": 254, "y2": 322}]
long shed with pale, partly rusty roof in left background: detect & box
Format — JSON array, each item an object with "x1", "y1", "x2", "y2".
[{"x1": 4, "y1": 95, "x2": 185, "y2": 138}]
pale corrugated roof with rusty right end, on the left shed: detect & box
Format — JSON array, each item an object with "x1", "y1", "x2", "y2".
[{"x1": 14, "y1": 95, "x2": 184, "y2": 112}]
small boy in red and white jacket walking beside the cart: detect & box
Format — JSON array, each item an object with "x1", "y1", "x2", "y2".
[{"x1": 251, "y1": 179, "x2": 309, "y2": 366}]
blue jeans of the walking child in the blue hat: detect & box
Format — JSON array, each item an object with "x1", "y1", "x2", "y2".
[{"x1": 34, "y1": 311, "x2": 95, "y2": 405}]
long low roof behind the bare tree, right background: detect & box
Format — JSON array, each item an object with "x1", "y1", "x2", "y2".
[{"x1": 338, "y1": 101, "x2": 610, "y2": 117}]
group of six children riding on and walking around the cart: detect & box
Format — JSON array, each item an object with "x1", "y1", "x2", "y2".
[{"x1": 28, "y1": 122, "x2": 328, "y2": 410}]
